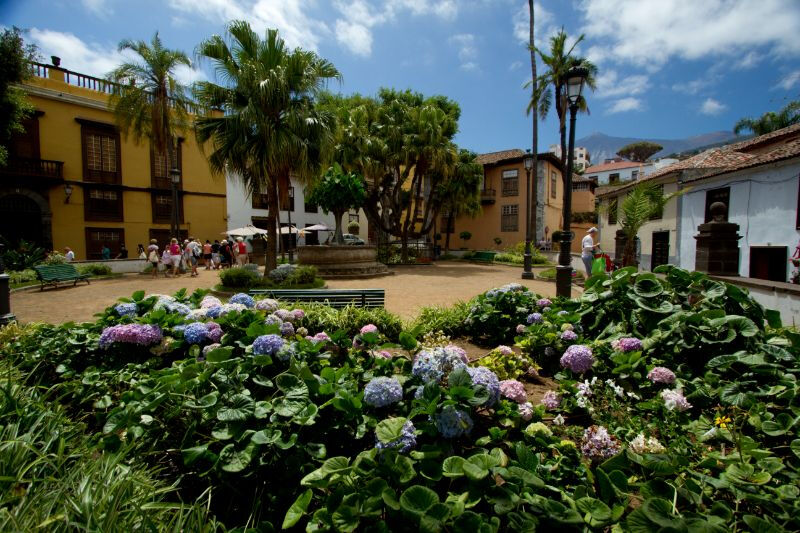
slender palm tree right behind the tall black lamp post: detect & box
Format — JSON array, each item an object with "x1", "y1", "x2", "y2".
[{"x1": 528, "y1": 29, "x2": 597, "y2": 166}]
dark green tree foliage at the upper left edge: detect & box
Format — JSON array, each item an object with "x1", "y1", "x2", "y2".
[{"x1": 0, "y1": 27, "x2": 37, "y2": 166}]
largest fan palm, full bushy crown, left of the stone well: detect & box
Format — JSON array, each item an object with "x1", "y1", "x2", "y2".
[{"x1": 195, "y1": 21, "x2": 340, "y2": 274}]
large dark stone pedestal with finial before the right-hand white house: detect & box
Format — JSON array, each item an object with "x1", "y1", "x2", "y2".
[{"x1": 694, "y1": 202, "x2": 742, "y2": 276}]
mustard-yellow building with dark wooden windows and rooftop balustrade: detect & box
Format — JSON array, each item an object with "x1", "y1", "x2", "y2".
[{"x1": 0, "y1": 59, "x2": 227, "y2": 259}]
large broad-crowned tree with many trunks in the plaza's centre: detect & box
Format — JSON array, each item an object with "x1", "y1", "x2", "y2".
[{"x1": 325, "y1": 89, "x2": 478, "y2": 261}]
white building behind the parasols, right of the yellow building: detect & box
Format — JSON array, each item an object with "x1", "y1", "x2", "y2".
[{"x1": 227, "y1": 175, "x2": 367, "y2": 252}]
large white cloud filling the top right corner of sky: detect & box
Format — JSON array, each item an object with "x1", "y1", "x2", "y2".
[{"x1": 579, "y1": 0, "x2": 800, "y2": 69}]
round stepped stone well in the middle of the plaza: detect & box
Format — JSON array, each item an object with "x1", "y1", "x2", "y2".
[{"x1": 297, "y1": 245, "x2": 391, "y2": 278}]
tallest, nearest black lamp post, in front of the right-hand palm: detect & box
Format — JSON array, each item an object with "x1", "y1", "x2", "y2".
[{"x1": 556, "y1": 67, "x2": 589, "y2": 298}]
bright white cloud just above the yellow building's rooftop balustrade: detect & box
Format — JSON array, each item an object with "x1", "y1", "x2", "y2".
[{"x1": 30, "y1": 28, "x2": 206, "y2": 84}]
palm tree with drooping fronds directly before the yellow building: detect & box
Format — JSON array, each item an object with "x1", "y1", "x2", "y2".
[{"x1": 109, "y1": 32, "x2": 192, "y2": 238}]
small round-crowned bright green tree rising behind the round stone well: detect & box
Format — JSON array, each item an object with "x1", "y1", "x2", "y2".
[{"x1": 307, "y1": 163, "x2": 366, "y2": 244}]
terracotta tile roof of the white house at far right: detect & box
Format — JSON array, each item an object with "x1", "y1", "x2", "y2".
[{"x1": 597, "y1": 124, "x2": 800, "y2": 197}]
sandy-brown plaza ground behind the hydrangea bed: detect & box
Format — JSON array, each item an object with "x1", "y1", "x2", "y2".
[{"x1": 11, "y1": 262, "x2": 580, "y2": 323}]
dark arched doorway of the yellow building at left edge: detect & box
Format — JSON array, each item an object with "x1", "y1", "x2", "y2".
[{"x1": 0, "y1": 191, "x2": 52, "y2": 249}]
